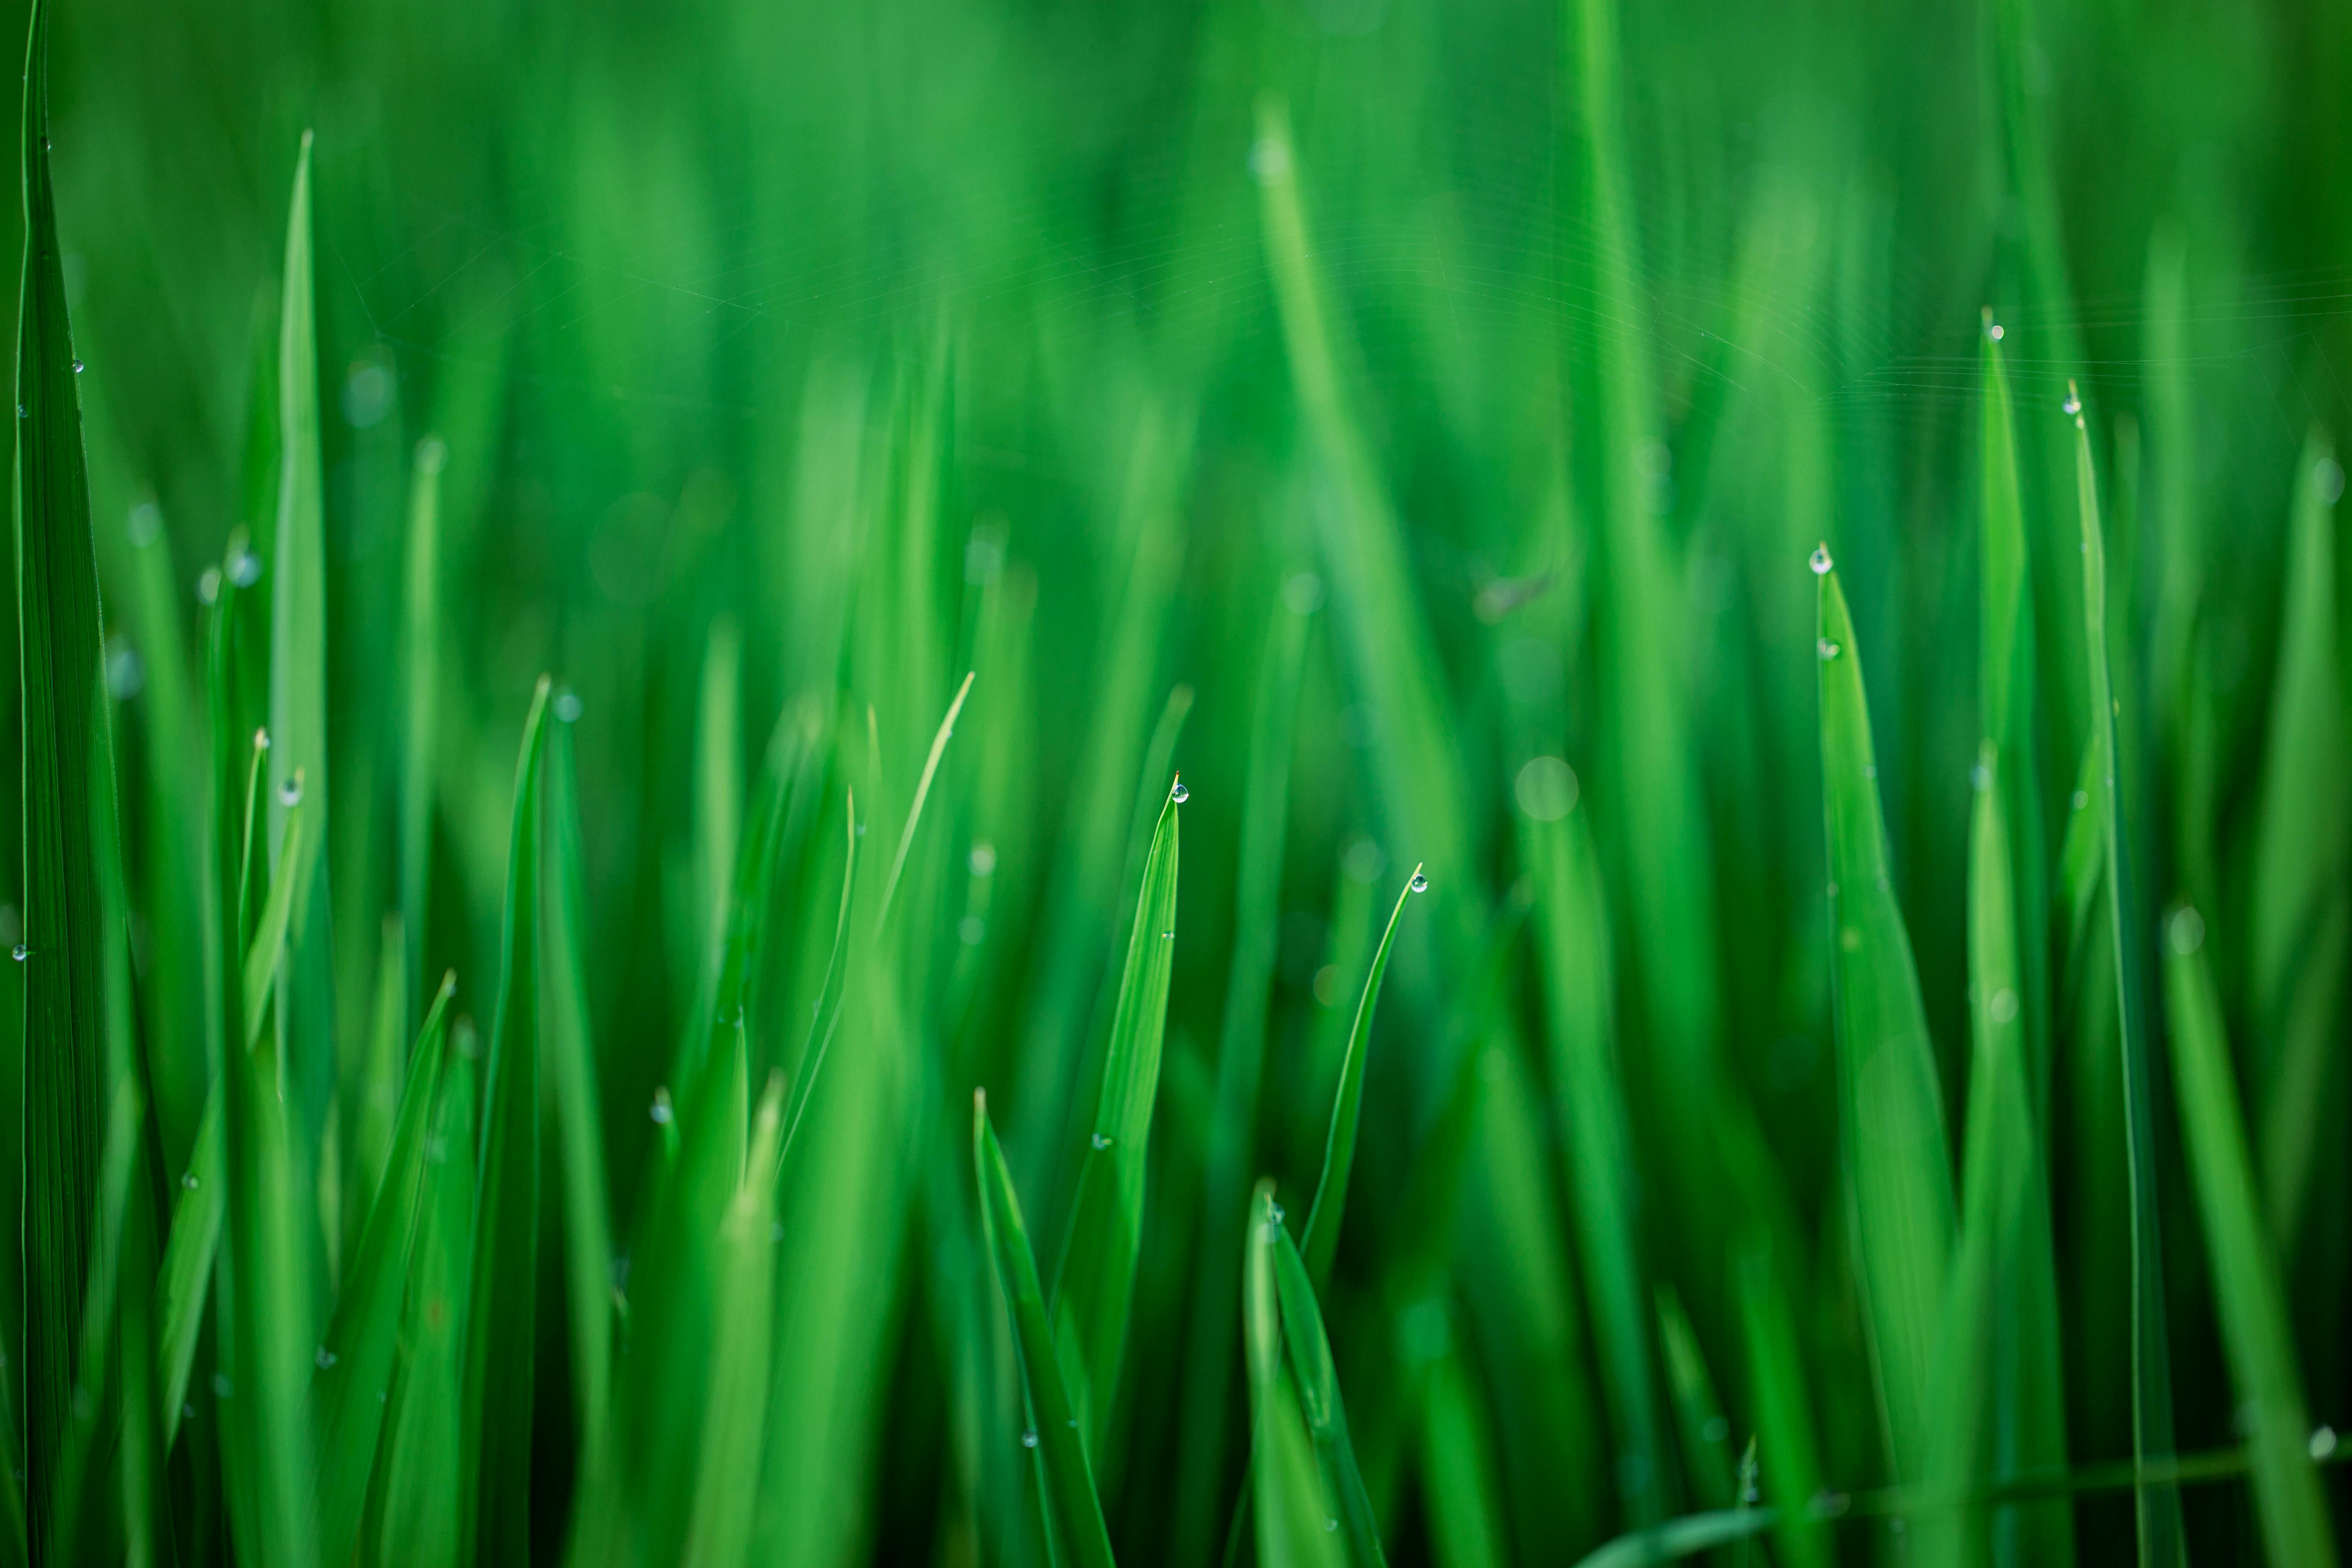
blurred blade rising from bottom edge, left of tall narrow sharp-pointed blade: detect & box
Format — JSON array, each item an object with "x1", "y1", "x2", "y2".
[{"x1": 360, "y1": 1025, "x2": 478, "y2": 1568}]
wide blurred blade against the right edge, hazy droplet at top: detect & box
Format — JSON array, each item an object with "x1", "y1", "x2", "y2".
[{"x1": 2248, "y1": 430, "x2": 2352, "y2": 1258}]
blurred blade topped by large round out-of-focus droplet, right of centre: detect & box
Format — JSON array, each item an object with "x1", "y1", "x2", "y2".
[{"x1": 1519, "y1": 799, "x2": 1670, "y2": 1519}]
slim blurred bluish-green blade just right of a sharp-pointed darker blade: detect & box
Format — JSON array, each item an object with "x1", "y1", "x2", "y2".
[{"x1": 543, "y1": 693, "x2": 612, "y2": 1455}]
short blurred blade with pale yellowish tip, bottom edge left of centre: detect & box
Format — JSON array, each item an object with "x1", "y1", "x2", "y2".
[{"x1": 682, "y1": 1072, "x2": 783, "y2": 1568}]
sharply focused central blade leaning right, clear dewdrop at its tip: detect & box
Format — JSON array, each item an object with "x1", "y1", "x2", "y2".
[{"x1": 1054, "y1": 778, "x2": 1190, "y2": 1455}]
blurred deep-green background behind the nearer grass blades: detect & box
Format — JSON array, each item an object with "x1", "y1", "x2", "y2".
[{"x1": 14, "y1": 0, "x2": 2352, "y2": 1568}]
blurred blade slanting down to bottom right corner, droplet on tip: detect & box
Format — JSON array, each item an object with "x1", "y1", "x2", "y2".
[{"x1": 2164, "y1": 905, "x2": 2336, "y2": 1563}]
